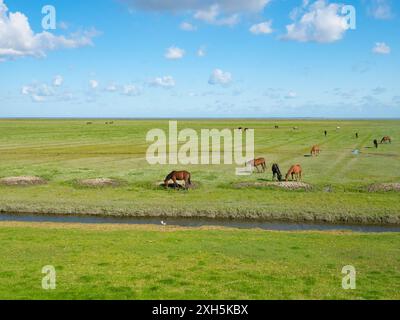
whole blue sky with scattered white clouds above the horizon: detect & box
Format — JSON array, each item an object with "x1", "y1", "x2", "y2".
[{"x1": 0, "y1": 0, "x2": 400, "y2": 118}]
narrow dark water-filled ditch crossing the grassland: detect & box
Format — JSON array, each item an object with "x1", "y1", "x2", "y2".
[{"x1": 0, "y1": 214, "x2": 400, "y2": 232}]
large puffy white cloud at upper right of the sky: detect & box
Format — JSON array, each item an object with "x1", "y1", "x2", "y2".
[{"x1": 283, "y1": 0, "x2": 349, "y2": 43}]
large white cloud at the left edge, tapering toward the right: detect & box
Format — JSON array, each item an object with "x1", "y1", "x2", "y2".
[{"x1": 0, "y1": 0, "x2": 98, "y2": 61}]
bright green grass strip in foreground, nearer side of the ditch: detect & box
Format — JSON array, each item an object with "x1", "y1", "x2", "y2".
[{"x1": 0, "y1": 222, "x2": 400, "y2": 299}]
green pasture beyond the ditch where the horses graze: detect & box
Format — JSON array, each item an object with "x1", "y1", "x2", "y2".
[{"x1": 0, "y1": 120, "x2": 400, "y2": 223}]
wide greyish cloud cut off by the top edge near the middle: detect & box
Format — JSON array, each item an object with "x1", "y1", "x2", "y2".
[{"x1": 121, "y1": 0, "x2": 271, "y2": 26}]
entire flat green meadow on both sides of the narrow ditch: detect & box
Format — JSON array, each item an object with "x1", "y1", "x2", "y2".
[{"x1": 0, "y1": 119, "x2": 400, "y2": 299}]
